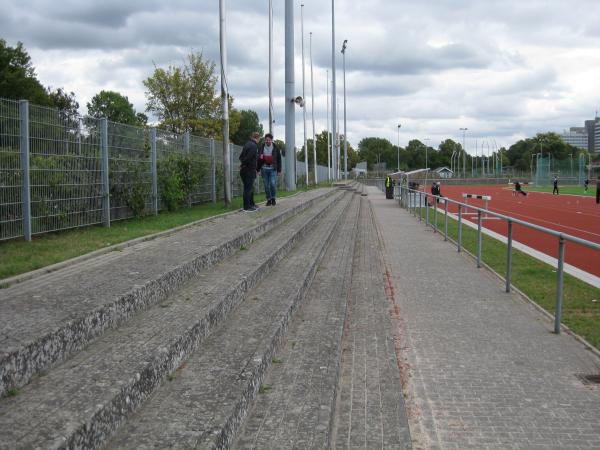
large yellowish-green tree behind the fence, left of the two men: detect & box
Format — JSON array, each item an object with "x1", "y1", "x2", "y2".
[{"x1": 144, "y1": 53, "x2": 240, "y2": 138}]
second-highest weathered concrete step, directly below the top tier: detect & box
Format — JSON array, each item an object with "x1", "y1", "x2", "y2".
[{"x1": 0, "y1": 193, "x2": 348, "y2": 448}]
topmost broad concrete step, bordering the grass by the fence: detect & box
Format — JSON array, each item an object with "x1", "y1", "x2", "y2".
[{"x1": 0, "y1": 189, "x2": 333, "y2": 396}]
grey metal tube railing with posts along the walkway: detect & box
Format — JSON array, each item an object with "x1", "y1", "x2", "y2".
[{"x1": 397, "y1": 186, "x2": 600, "y2": 334}]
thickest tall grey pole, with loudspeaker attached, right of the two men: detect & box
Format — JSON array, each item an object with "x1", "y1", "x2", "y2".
[{"x1": 285, "y1": 0, "x2": 296, "y2": 191}]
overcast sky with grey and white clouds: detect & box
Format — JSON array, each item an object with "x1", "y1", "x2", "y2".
[{"x1": 0, "y1": 0, "x2": 600, "y2": 152}]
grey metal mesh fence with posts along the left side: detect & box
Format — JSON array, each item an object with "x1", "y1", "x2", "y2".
[{"x1": 0, "y1": 99, "x2": 338, "y2": 241}]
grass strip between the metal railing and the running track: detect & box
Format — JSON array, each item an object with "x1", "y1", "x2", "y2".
[{"x1": 417, "y1": 208, "x2": 600, "y2": 348}]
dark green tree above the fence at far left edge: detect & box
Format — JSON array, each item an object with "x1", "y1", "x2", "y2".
[{"x1": 0, "y1": 39, "x2": 52, "y2": 106}]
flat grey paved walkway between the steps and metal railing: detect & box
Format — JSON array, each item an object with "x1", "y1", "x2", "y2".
[{"x1": 368, "y1": 188, "x2": 600, "y2": 449}]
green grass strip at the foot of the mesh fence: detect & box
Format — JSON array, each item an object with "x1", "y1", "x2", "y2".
[{"x1": 0, "y1": 184, "x2": 323, "y2": 287}]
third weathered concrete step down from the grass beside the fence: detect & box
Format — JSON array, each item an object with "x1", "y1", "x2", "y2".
[{"x1": 107, "y1": 195, "x2": 356, "y2": 449}]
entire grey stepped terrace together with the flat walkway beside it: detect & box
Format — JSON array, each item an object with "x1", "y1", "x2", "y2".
[{"x1": 0, "y1": 184, "x2": 600, "y2": 449}]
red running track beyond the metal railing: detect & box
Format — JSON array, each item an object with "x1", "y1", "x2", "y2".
[{"x1": 425, "y1": 185, "x2": 600, "y2": 276}]
